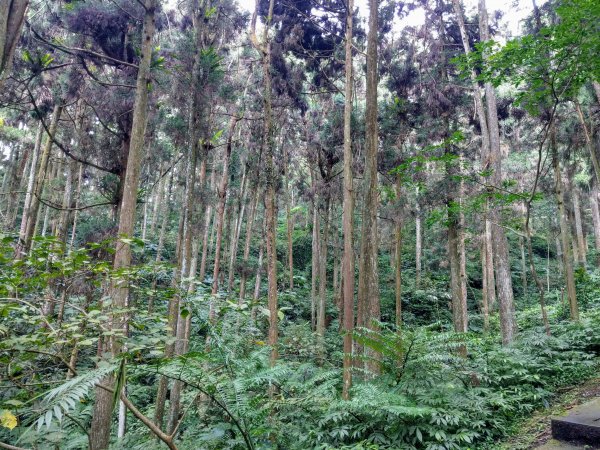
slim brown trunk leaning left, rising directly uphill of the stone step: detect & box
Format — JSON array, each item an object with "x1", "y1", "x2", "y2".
[{"x1": 550, "y1": 125, "x2": 579, "y2": 320}]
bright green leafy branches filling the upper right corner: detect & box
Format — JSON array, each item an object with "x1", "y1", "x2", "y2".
[{"x1": 455, "y1": 0, "x2": 600, "y2": 114}]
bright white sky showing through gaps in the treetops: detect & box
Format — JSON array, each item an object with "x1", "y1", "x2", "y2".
[{"x1": 238, "y1": 0, "x2": 544, "y2": 36}]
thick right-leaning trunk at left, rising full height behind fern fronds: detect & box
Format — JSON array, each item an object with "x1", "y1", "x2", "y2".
[{"x1": 90, "y1": 0, "x2": 157, "y2": 450}]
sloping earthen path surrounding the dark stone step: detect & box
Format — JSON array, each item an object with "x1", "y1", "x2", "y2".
[{"x1": 498, "y1": 377, "x2": 600, "y2": 450}]
